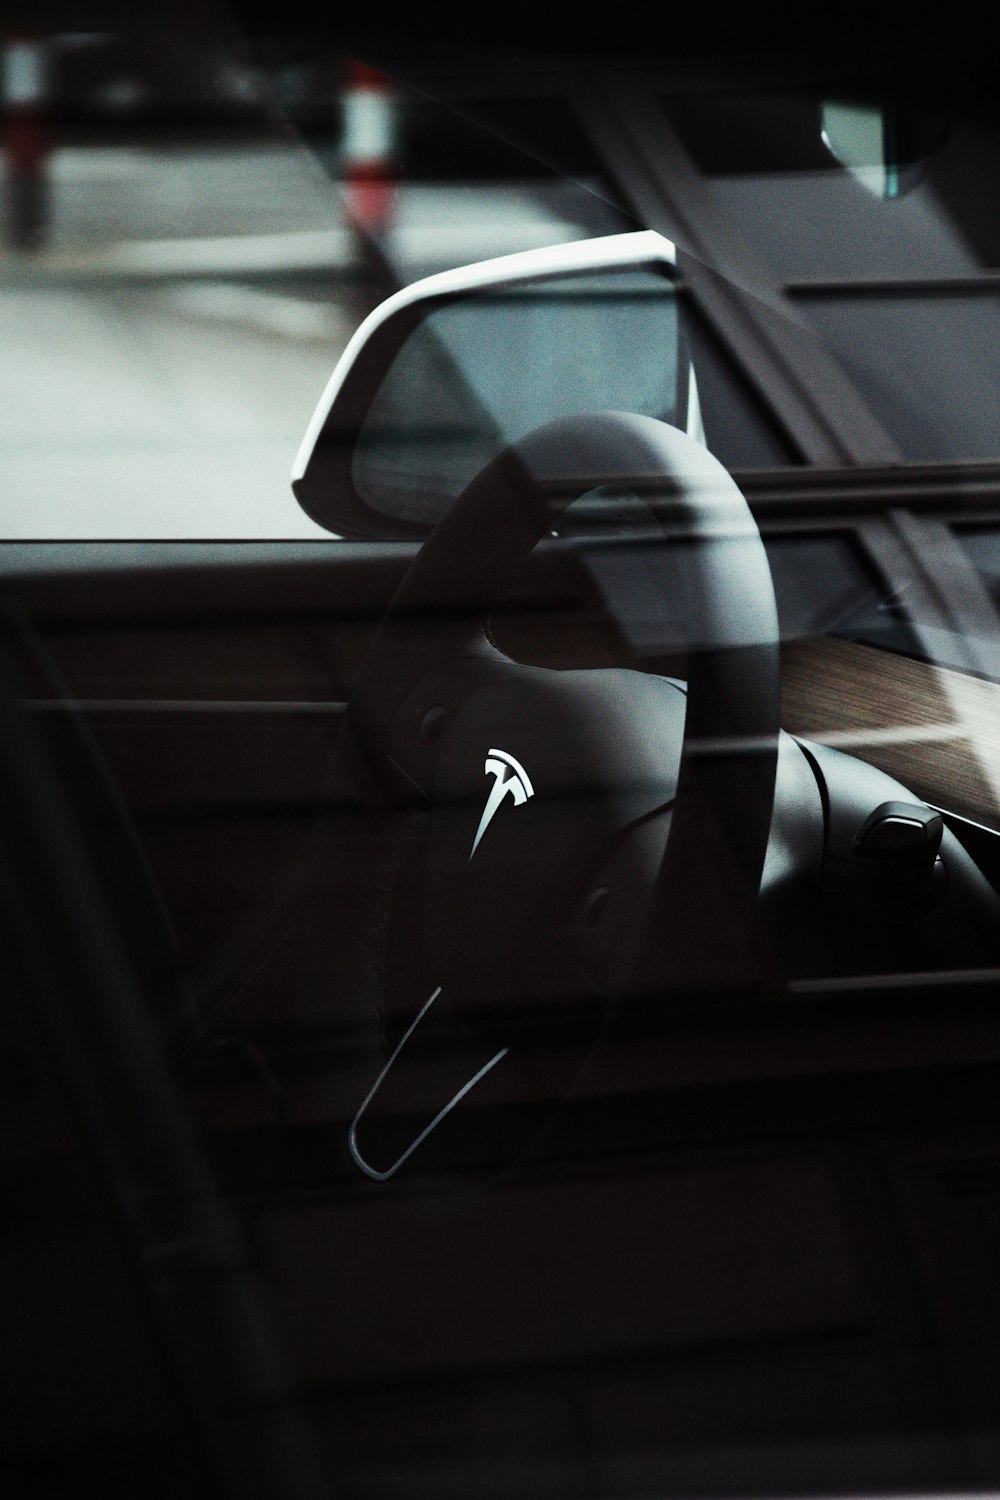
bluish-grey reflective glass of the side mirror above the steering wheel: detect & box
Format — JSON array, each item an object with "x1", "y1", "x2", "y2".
[{"x1": 352, "y1": 267, "x2": 687, "y2": 522}]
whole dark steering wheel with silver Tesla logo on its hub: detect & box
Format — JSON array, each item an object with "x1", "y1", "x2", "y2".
[{"x1": 337, "y1": 411, "x2": 780, "y2": 1179}]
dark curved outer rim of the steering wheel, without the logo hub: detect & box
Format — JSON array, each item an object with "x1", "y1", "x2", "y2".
[{"x1": 335, "y1": 413, "x2": 780, "y2": 1160}]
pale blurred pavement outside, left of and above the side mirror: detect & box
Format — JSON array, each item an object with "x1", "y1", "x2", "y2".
[{"x1": 0, "y1": 138, "x2": 600, "y2": 539}]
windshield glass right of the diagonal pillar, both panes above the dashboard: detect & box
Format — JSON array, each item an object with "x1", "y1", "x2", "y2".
[{"x1": 661, "y1": 80, "x2": 1000, "y2": 461}]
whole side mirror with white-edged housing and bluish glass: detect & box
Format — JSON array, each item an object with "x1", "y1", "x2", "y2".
[{"x1": 292, "y1": 231, "x2": 702, "y2": 539}]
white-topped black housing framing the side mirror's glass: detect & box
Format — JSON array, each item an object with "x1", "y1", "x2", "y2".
[{"x1": 292, "y1": 230, "x2": 680, "y2": 540}]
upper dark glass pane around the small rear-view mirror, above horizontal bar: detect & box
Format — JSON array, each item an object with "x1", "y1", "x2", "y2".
[{"x1": 663, "y1": 87, "x2": 1000, "y2": 282}]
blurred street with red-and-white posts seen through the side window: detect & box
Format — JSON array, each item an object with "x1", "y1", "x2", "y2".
[{"x1": 0, "y1": 24, "x2": 631, "y2": 539}]
